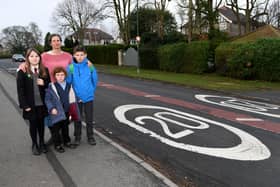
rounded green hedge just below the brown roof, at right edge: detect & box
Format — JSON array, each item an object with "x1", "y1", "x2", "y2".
[{"x1": 227, "y1": 39, "x2": 280, "y2": 81}]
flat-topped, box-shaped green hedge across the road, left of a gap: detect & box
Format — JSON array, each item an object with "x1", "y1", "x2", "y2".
[{"x1": 158, "y1": 42, "x2": 209, "y2": 73}]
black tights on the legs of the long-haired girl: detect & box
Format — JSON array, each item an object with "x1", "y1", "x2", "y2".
[{"x1": 29, "y1": 107, "x2": 45, "y2": 145}]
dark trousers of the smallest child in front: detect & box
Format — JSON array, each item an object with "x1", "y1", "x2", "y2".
[{"x1": 50, "y1": 113, "x2": 71, "y2": 146}]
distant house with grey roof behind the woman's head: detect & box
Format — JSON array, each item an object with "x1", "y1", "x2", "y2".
[{"x1": 70, "y1": 28, "x2": 114, "y2": 45}]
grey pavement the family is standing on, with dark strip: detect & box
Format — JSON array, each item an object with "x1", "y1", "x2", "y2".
[{"x1": 0, "y1": 69, "x2": 173, "y2": 187}]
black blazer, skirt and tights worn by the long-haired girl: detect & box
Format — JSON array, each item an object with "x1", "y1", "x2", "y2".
[{"x1": 17, "y1": 67, "x2": 50, "y2": 153}]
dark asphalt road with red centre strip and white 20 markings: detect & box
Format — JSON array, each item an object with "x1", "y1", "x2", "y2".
[{"x1": 1, "y1": 58, "x2": 280, "y2": 187}]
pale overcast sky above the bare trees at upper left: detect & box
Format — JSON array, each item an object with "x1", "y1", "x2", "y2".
[{"x1": 0, "y1": 0, "x2": 177, "y2": 38}]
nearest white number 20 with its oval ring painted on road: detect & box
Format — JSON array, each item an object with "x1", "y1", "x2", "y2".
[{"x1": 114, "y1": 104, "x2": 271, "y2": 161}]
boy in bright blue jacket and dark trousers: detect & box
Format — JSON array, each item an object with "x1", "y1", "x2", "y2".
[{"x1": 67, "y1": 46, "x2": 98, "y2": 146}]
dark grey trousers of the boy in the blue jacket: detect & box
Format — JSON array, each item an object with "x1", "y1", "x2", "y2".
[{"x1": 74, "y1": 101, "x2": 93, "y2": 139}]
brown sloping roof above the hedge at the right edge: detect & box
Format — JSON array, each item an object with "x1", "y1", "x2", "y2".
[{"x1": 233, "y1": 25, "x2": 280, "y2": 42}]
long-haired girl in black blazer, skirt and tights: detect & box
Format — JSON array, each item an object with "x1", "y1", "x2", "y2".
[{"x1": 17, "y1": 48, "x2": 50, "y2": 155}]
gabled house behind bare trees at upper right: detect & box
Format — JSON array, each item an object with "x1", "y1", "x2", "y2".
[{"x1": 218, "y1": 6, "x2": 263, "y2": 36}]
